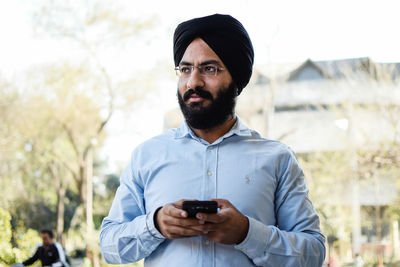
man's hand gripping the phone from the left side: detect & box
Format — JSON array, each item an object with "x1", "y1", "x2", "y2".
[{"x1": 155, "y1": 199, "x2": 203, "y2": 238}]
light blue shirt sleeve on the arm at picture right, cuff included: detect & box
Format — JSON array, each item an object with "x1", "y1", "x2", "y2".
[{"x1": 235, "y1": 151, "x2": 325, "y2": 267}]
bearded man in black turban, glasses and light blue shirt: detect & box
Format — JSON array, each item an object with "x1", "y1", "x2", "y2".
[{"x1": 100, "y1": 14, "x2": 325, "y2": 267}]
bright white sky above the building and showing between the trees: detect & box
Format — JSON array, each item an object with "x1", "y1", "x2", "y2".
[{"x1": 0, "y1": 0, "x2": 400, "y2": 172}]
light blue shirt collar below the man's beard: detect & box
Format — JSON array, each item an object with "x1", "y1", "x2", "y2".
[{"x1": 175, "y1": 115, "x2": 251, "y2": 143}]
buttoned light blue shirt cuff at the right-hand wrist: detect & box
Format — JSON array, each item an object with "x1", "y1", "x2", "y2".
[{"x1": 235, "y1": 217, "x2": 272, "y2": 259}]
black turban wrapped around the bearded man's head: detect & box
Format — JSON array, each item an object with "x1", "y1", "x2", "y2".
[{"x1": 174, "y1": 14, "x2": 254, "y2": 94}]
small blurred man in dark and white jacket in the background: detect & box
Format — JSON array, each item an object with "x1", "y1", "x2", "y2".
[{"x1": 22, "y1": 230, "x2": 69, "y2": 267}]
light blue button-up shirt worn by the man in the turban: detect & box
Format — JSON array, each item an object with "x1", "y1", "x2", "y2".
[{"x1": 100, "y1": 118, "x2": 325, "y2": 267}]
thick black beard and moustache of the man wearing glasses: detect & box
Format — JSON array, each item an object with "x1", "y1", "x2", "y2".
[{"x1": 177, "y1": 82, "x2": 237, "y2": 130}]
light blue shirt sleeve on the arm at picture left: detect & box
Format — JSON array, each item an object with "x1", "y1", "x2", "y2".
[{"x1": 100, "y1": 160, "x2": 165, "y2": 264}]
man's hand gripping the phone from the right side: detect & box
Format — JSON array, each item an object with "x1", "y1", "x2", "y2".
[{"x1": 191, "y1": 199, "x2": 249, "y2": 245}]
